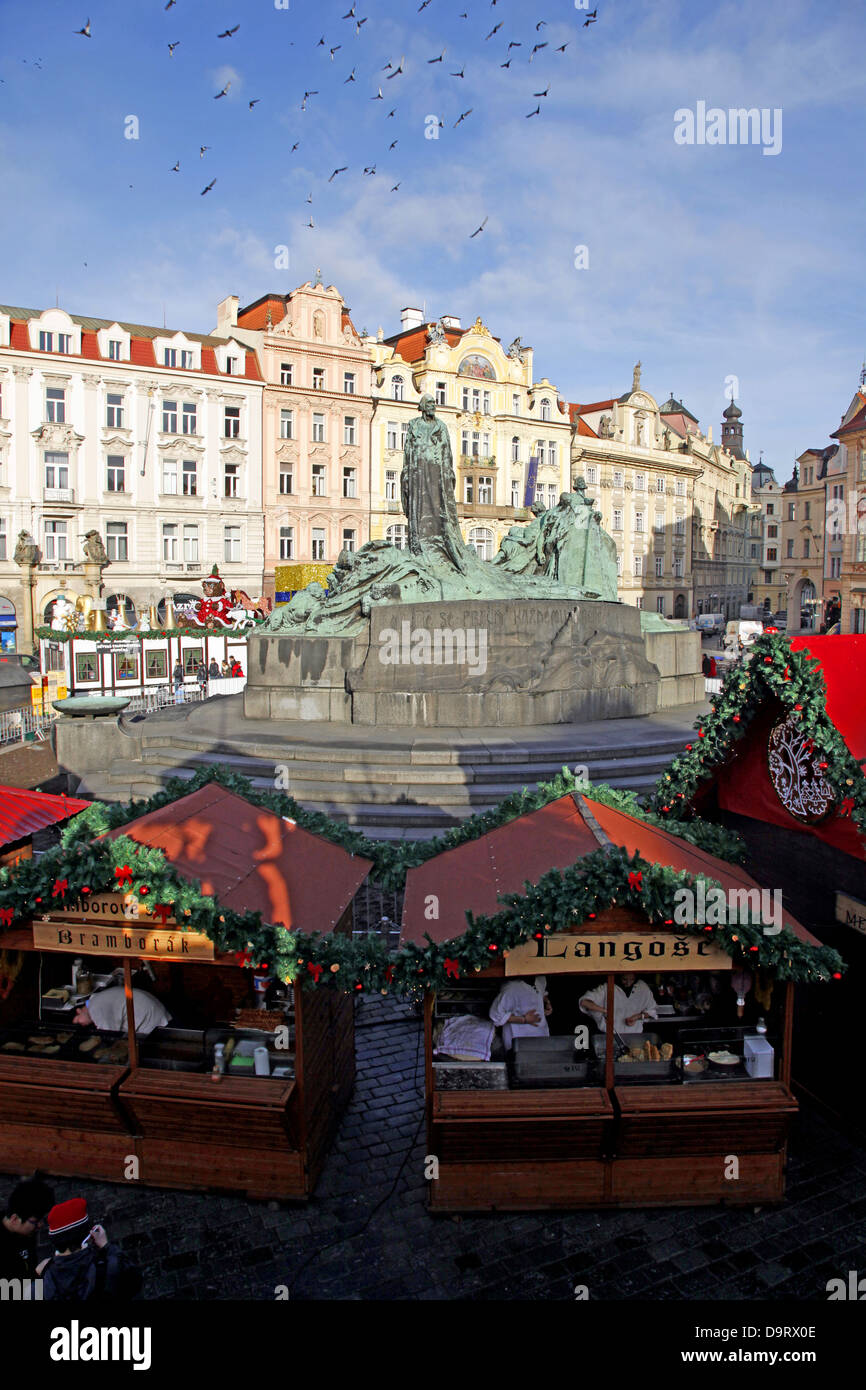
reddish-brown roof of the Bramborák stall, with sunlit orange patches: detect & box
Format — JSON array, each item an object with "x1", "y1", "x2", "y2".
[{"x1": 110, "y1": 783, "x2": 373, "y2": 931}]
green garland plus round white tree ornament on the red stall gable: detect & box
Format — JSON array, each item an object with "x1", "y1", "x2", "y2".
[{"x1": 649, "y1": 634, "x2": 866, "y2": 840}]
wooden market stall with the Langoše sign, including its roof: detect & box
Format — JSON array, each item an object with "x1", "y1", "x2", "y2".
[{"x1": 403, "y1": 795, "x2": 839, "y2": 1211}]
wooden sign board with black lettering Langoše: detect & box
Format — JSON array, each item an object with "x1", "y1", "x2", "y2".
[{"x1": 505, "y1": 931, "x2": 731, "y2": 974}]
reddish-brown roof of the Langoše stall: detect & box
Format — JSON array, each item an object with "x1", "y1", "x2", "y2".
[{"x1": 403, "y1": 795, "x2": 819, "y2": 945}]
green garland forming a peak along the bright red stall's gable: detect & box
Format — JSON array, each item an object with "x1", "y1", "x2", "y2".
[{"x1": 649, "y1": 634, "x2": 866, "y2": 838}]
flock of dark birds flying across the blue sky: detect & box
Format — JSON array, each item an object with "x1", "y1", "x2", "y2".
[{"x1": 67, "y1": 0, "x2": 598, "y2": 239}]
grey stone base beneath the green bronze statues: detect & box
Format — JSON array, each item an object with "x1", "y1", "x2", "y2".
[{"x1": 243, "y1": 599, "x2": 703, "y2": 728}]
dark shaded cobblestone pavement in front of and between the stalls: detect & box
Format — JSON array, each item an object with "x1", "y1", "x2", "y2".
[{"x1": 6, "y1": 999, "x2": 866, "y2": 1301}]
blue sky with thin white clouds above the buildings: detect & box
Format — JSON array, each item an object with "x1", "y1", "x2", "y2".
[{"x1": 0, "y1": 0, "x2": 866, "y2": 480}]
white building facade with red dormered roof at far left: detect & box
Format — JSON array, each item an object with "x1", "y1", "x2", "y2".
[{"x1": 0, "y1": 306, "x2": 263, "y2": 649}]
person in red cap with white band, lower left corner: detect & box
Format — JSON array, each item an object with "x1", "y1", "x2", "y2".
[{"x1": 38, "y1": 1197, "x2": 142, "y2": 1302}]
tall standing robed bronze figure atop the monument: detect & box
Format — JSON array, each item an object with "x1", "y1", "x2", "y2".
[{"x1": 400, "y1": 396, "x2": 467, "y2": 574}]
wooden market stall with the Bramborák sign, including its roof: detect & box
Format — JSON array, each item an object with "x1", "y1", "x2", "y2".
[{"x1": 0, "y1": 783, "x2": 370, "y2": 1198}]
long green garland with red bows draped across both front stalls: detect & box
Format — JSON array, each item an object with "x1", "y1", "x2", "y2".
[{"x1": 0, "y1": 835, "x2": 845, "y2": 998}]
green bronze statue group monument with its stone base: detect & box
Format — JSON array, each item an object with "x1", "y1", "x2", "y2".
[{"x1": 245, "y1": 396, "x2": 703, "y2": 728}]
